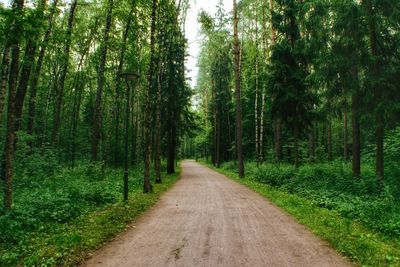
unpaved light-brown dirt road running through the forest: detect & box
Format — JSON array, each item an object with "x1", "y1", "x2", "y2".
[{"x1": 85, "y1": 161, "x2": 350, "y2": 267}]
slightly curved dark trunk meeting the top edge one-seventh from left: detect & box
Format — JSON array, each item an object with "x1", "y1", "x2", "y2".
[{"x1": 27, "y1": 0, "x2": 58, "y2": 142}]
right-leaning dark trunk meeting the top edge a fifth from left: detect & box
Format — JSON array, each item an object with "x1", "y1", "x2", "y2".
[{"x1": 51, "y1": 0, "x2": 78, "y2": 145}]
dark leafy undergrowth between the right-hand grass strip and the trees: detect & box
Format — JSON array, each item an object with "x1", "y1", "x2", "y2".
[{"x1": 217, "y1": 161, "x2": 400, "y2": 243}]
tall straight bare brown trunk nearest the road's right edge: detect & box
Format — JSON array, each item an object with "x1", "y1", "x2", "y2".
[{"x1": 233, "y1": 0, "x2": 244, "y2": 177}]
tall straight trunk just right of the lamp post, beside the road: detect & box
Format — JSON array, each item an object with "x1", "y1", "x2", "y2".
[{"x1": 143, "y1": 0, "x2": 157, "y2": 193}]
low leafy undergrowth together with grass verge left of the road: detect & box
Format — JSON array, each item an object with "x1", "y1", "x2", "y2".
[{"x1": 0, "y1": 163, "x2": 179, "y2": 266}]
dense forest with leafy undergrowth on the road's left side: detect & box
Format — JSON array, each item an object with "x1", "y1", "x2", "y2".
[{"x1": 0, "y1": 0, "x2": 194, "y2": 266}]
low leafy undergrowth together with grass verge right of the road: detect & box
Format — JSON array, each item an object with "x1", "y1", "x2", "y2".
[{"x1": 206, "y1": 162, "x2": 400, "y2": 266}]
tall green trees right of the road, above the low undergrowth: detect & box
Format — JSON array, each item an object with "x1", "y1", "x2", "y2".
[{"x1": 185, "y1": 0, "x2": 400, "y2": 189}]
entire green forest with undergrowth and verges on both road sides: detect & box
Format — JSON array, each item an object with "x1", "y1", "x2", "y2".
[{"x1": 0, "y1": 0, "x2": 400, "y2": 266}]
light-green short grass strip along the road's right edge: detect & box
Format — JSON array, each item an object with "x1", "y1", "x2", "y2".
[{"x1": 203, "y1": 162, "x2": 400, "y2": 266}]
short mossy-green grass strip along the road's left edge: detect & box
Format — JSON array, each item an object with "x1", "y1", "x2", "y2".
[{"x1": 2, "y1": 171, "x2": 179, "y2": 266}]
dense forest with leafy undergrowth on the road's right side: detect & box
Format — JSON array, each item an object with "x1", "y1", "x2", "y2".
[{"x1": 184, "y1": 0, "x2": 400, "y2": 266}]
